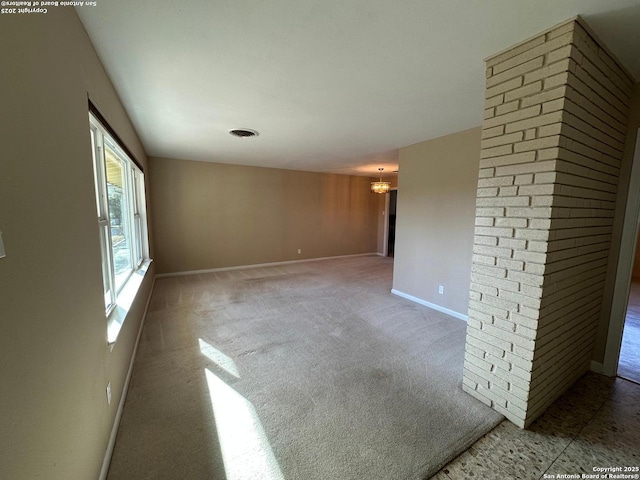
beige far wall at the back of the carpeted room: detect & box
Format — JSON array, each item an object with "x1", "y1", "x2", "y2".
[{"x1": 150, "y1": 158, "x2": 380, "y2": 273}]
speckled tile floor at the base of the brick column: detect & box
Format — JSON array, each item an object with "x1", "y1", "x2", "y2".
[{"x1": 432, "y1": 373, "x2": 640, "y2": 480}]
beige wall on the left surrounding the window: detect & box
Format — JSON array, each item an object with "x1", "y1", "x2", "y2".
[{"x1": 0, "y1": 7, "x2": 153, "y2": 480}]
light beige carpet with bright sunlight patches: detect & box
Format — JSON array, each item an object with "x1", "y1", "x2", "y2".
[{"x1": 109, "y1": 256, "x2": 502, "y2": 480}]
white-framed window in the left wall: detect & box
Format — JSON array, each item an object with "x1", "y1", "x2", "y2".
[{"x1": 89, "y1": 114, "x2": 149, "y2": 315}]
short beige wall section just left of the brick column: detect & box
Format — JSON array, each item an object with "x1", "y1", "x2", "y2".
[{"x1": 393, "y1": 128, "x2": 480, "y2": 315}]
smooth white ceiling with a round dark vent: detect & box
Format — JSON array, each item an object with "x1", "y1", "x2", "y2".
[{"x1": 77, "y1": 0, "x2": 640, "y2": 175}]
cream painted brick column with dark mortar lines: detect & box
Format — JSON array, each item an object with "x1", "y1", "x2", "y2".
[{"x1": 463, "y1": 19, "x2": 633, "y2": 427}]
